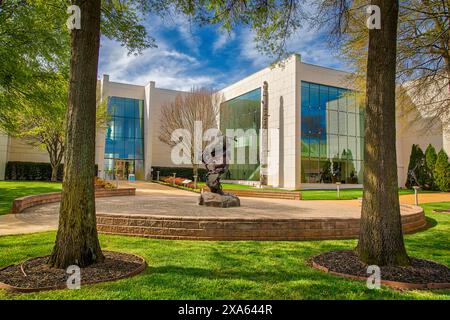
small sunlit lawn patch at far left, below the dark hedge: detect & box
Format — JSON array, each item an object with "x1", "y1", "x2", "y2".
[{"x1": 0, "y1": 181, "x2": 61, "y2": 215}]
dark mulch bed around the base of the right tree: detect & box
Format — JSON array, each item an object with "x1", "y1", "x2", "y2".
[{"x1": 310, "y1": 250, "x2": 450, "y2": 289}]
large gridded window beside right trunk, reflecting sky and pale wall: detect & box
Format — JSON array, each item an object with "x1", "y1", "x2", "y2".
[{"x1": 301, "y1": 81, "x2": 364, "y2": 183}]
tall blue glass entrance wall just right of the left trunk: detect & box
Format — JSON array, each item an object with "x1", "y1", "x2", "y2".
[{"x1": 104, "y1": 97, "x2": 144, "y2": 180}]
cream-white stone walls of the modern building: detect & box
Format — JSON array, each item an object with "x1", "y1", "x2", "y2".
[{"x1": 0, "y1": 55, "x2": 450, "y2": 189}]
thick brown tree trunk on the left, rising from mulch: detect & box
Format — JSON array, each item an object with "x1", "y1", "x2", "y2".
[{"x1": 49, "y1": 0, "x2": 104, "y2": 268}]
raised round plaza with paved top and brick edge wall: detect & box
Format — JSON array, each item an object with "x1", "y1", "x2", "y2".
[{"x1": 16, "y1": 187, "x2": 426, "y2": 240}]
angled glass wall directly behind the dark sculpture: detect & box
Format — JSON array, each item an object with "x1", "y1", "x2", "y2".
[{"x1": 220, "y1": 88, "x2": 261, "y2": 181}]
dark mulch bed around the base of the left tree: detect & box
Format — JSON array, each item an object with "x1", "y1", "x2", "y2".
[{"x1": 0, "y1": 251, "x2": 147, "y2": 292}]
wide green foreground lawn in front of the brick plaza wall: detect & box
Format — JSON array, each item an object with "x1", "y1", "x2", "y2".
[{"x1": 0, "y1": 202, "x2": 450, "y2": 300}]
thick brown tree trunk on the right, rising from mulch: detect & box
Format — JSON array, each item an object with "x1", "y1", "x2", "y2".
[{"x1": 356, "y1": 0, "x2": 409, "y2": 266}]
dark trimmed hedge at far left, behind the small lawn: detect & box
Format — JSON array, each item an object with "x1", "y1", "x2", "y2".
[{"x1": 5, "y1": 161, "x2": 98, "y2": 181}]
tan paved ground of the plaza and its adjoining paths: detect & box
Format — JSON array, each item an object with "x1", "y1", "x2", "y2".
[{"x1": 0, "y1": 182, "x2": 450, "y2": 235}]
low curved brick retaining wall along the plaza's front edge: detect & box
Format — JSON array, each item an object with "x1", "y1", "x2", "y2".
[{"x1": 97, "y1": 207, "x2": 427, "y2": 240}]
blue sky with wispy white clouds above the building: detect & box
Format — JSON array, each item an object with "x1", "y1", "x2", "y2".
[{"x1": 99, "y1": 13, "x2": 345, "y2": 90}]
